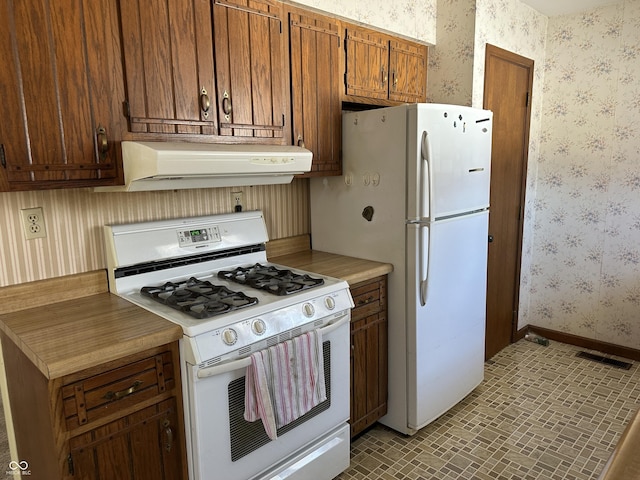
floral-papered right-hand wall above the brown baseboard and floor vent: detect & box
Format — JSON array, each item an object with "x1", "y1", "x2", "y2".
[{"x1": 526, "y1": 0, "x2": 640, "y2": 349}]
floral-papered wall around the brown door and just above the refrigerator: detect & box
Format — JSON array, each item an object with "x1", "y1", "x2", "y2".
[{"x1": 427, "y1": 0, "x2": 548, "y2": 336}]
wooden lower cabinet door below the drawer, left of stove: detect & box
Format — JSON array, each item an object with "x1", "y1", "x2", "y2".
[{"x1": 68, "y1": 398, "x2": 184, "y2": 480}]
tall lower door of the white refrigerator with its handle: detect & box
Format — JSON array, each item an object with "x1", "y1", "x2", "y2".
[{"x1": 407, "y1": 211, "x2": 489, "y2": 430}]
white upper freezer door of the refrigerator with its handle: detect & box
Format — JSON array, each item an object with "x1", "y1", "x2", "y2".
[{"x1": 407, "y1": 104, "x2": 493, "y2": 221}]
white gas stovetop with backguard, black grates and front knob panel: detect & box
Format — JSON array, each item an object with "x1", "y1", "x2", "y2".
[{"x1": 105, "y1": 212, "x2": 353, "y2": 364}]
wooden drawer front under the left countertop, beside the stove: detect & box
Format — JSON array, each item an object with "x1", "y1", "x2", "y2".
[{"x1": 62, "y1": 351, "x2": 175, "y2": 430}]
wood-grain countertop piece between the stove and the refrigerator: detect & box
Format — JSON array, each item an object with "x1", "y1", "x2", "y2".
[{"x1": 269, "y1": 250, "x2": 393, "y2": 285}]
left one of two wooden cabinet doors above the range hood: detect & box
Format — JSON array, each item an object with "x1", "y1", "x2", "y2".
[{"x1": 120, "y1": 0, "x2": 217, "y2": 135}]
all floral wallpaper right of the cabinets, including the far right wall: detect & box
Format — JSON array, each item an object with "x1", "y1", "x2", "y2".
[{"x1": 427, "y1": 0, "x2": 640, "y2": 349}]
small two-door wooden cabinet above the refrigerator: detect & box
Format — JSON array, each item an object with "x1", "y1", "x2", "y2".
[{"x1": 344, "y1": 25, "x2": 427, "y2": 105}]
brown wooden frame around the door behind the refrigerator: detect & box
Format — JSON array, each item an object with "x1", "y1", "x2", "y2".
[{"x1": 483, "y1": 43, "x2": 534, "y2": 354}]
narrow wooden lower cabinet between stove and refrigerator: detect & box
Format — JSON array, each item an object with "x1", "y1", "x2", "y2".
[{"x1": 349, "y1": 276, "x2": 387, "y2": 437}]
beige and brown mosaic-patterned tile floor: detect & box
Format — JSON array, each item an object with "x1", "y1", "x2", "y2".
[{"x1": 337, "y1": 340, "x2": 640, "y2": 480}]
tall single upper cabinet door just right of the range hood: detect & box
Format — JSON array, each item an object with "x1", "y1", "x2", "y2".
[{"x1": 289, "y1": 9, "x2": 342, "y2": 176}]
